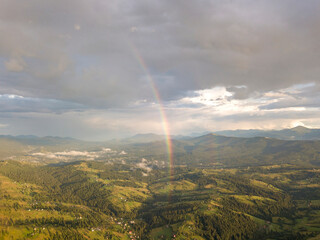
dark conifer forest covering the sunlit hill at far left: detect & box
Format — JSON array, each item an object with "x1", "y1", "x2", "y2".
[{"x1": 0, "y1": 161, "x2": 116, "y2": 214}]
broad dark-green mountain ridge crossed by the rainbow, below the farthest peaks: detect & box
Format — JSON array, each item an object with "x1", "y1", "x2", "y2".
[{"x1": 125, "y1": 134, "x2": 320, "y2": 167}]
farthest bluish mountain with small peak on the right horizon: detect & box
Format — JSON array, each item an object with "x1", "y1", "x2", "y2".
[{"x1": 215, "y1": 126, "x2": 320, "y2": 140}]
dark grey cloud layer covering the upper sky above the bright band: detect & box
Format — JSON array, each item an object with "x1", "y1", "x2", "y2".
[{"x1": 0, "y1": 0, "x2": 320, "y2": 107}]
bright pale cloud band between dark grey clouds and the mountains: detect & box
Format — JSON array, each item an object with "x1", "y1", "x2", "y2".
[{"x1": 0, "y1": 84, "x2": 320, "y2": 140}]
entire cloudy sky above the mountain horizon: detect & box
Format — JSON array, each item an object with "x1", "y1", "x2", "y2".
[{"x1": 0, "y1": 0, "x2": 320, "y2": 140}]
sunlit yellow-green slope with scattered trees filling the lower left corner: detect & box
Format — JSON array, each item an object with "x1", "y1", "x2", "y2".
[{"x1": 0, "y1": 161, "x2": 148, "y2": 239}]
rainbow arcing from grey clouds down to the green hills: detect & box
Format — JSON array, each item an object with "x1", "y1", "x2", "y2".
[{"x1": 130, "y1": 44, "x2": 174, "y2": 201}]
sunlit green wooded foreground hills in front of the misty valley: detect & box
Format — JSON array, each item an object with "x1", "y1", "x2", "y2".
[{"x1": 0, "y1": 161, "x2": 320, "y2": 239}]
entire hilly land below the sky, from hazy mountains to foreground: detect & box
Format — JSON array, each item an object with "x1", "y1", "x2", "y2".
[{"x1": 0, "y1": 134, "x2": 320, "y2": 240}]
